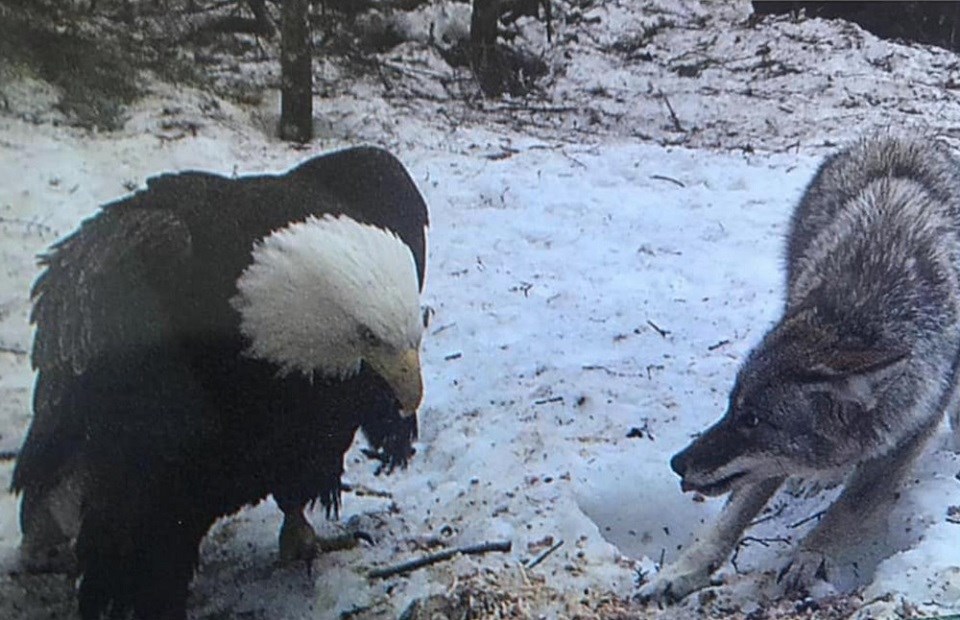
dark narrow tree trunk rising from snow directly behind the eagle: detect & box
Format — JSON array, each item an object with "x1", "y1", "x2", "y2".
[{"x1": 280, "y1": 0, "x2": 313, "y2": 142}]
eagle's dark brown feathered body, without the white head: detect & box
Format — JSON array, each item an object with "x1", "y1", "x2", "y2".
[{"x1": 13, "y1": 147, "x2": 427, "y2": 620}]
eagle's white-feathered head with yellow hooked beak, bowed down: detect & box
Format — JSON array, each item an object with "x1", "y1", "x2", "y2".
[{"x1": 231, "y1": 215, "x2": 423, "y2": 414}]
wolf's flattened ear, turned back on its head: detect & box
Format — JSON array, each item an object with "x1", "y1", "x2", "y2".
[{"x1": 810, "y1": 349, "x2": 910, "y2": 411}]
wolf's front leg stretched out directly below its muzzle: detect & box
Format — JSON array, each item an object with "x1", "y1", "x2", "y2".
[{"x1": 640, "y1": 478, "x2": 783, "y2": 603}]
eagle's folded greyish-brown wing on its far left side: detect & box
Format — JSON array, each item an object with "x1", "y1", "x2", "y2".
[{"x1": 12, "y1": 203, "x2": 191, "y2": 490}]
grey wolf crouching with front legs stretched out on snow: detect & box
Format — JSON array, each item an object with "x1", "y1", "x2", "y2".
[{"x1": 640, "y1": 131, "x2": 960, "y2": 603}]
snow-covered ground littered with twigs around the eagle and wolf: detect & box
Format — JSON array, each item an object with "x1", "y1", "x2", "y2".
[{"x1": 0, "y1": 2, "x2": 960, "y2": 618}]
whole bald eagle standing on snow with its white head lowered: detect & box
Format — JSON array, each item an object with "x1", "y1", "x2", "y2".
[{"x1": 12, "y1": 147, "x2": 428, "y2": 620}]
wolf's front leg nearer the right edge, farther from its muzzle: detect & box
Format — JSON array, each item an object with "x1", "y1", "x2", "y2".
[{"x1": 777, "y1": 429, "x2": 930, "y2": 594}]
